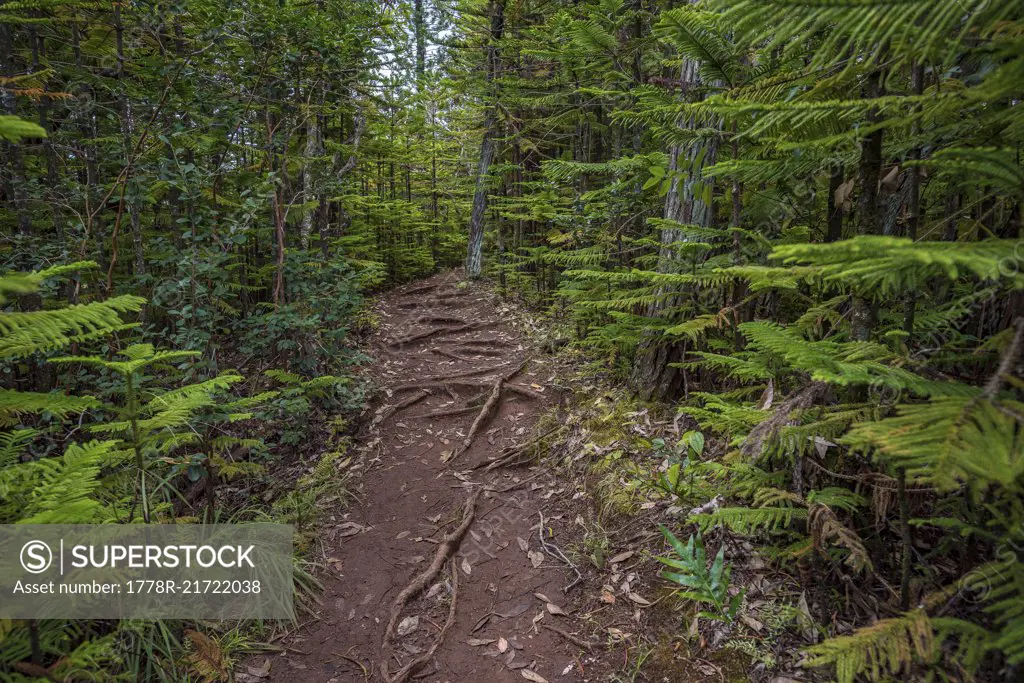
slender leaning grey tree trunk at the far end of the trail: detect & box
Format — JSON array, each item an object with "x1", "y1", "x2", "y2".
[{"x1": 466, "y1": 0, "x2": 505, "y2": 278}]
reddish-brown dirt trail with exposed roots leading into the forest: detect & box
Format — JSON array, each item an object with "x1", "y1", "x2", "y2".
[{"x1": 257, "y1": 273, "x2": 595, "y2": 683}]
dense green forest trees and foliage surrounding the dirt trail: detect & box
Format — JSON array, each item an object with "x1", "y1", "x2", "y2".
[{"x1": 0, "y1": 0, "x2": 1024, "y2": 681}]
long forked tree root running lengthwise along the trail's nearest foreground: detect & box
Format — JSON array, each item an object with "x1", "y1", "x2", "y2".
[{"x1": 380, "y1": 488, "x2": 481, "y2": 683}]
